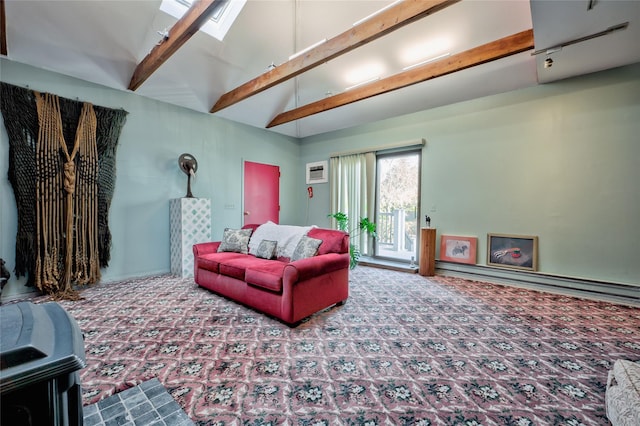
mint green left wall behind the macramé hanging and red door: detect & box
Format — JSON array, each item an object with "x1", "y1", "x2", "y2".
[{"x1": 0, "y1": 59, "x2": 300, "y2": 298}]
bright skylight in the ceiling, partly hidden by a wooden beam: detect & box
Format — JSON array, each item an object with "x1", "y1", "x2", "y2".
[{"x1": 160, "y1": 0, "x2": 247, "y2": 41}]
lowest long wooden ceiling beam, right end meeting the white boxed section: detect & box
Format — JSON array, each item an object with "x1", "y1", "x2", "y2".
[{"x1": 267, "y1": 29, "x2": 534, "y2": 128}]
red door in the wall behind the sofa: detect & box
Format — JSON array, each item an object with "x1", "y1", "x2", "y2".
[{"x1": 244, "y1": 161, "x2": 280, "y2": 225}]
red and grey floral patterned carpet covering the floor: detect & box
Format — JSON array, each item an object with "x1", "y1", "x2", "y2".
[{"x1": 42, "y1": 266, "x2": 640, "y2": 426}]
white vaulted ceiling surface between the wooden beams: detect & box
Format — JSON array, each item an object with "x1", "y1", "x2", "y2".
[{"x1": 5, "y1": 0, "x2": 640, "y2": 137}]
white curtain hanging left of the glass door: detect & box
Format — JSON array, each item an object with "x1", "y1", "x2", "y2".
[{"x1": 329, "y1": 152, "x2": 376, "y2": 255}]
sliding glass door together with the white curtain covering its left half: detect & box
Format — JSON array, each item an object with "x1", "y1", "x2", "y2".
[{"x1": 329, "y1": 139, "x2": 424, "y2": 265}]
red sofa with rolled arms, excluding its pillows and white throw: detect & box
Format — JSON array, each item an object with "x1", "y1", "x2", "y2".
[{"x1": 193, "y1": 225, "x2": 349, "y2": 325}]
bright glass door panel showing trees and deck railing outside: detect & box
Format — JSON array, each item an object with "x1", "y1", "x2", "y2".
[{"x1": 375, "y1": 151, "x2": 421, "y2": 264}]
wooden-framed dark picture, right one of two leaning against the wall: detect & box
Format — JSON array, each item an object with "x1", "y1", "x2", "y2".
[{"x1": 487, "y1": 234, "x2": 538, "y2": 271}]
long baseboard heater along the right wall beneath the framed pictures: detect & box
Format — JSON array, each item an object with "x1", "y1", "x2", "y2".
[{"x1": 436, "y1": 261, "x2": 640, "y2": 307}]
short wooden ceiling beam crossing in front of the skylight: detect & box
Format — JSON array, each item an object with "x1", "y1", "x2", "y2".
[{"x1": 129, "y1": 0, "x2": 221, "y2": 90}]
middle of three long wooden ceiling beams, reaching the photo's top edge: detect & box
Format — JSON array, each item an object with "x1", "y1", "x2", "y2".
[{"x1": 210, "y1": 0, "x2": 460, "y2": 113}]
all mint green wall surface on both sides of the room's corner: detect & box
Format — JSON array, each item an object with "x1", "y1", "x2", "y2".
[{"x1": 0, "y1": 59, "x2": 640, "y2": 298}]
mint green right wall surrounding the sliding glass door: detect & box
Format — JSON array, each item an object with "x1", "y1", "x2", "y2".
[{"x1": 299, "y1": 64, "x2": 640, "y2": 285}]
